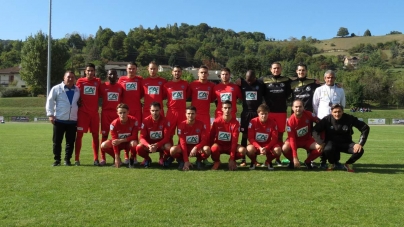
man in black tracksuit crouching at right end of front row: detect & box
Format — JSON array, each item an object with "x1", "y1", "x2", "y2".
[{"x1": 313, "y1": 103, "x2": 370, "y2": 172}]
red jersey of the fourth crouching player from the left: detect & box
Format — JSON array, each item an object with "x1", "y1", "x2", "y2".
[{"x1": 210, "y1": 117, "x2": 240, "y2": 160}]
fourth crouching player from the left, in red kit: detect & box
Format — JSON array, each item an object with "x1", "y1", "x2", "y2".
[{"x1": 210, "y1": 100, "x2": 246, "y2": 170}]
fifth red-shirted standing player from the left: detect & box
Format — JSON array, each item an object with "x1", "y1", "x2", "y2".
[{"x1": 163, "y1": 65, "x2": 188, "y2": 143}]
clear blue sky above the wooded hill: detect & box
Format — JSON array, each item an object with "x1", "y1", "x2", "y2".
[{"x1": 0, "y1": 0, "x2": 404, "y2": 41}]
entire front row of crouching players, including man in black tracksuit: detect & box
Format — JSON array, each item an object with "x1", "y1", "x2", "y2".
[{"x1": 101, "y1": 100, "x2": 369, "y2": 172}]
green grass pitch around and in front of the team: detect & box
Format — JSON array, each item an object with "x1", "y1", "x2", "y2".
[{"x1": 0, "y1": 123, "x2": 404, "y2": 226}]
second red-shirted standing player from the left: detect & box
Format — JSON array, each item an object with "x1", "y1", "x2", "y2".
[{"x1": 100, "y1": 69, "x2": 122, "y2": 166}]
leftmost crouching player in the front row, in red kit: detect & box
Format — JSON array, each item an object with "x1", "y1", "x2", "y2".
[{"x1": 101, "y1": 103, "x2": 139, "y2": 168}]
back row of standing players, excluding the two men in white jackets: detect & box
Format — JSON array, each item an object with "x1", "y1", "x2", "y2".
[{"x1": 75, "y1": 62, "x2": 344, "y2": 168}]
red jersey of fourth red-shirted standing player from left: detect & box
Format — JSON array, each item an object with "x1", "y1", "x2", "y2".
[{"x1": 142, "y1": 77, "x2": 167, "y2": 113}]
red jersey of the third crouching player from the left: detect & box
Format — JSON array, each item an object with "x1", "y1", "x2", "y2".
[{"x1": 177, "y1": 120, "x2": 208, "y2": 162}]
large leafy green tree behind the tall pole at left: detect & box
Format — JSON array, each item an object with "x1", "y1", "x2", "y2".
[{"x1": 20, "y1": 31, "x2": 69, "y2": 95}]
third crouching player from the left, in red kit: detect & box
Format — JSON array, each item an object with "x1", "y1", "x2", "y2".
[{"x1": 170, "y1": 106, "x2": 211, "y2": 170}]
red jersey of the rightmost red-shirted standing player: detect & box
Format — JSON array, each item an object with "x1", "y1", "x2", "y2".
[{"x1": 214, "y1": 83, "x2": 242, "y2": 116}]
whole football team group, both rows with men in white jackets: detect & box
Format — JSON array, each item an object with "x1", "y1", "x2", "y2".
[{"x1": 46, "y1": 62, "x2": 370, "y2": 172}]
